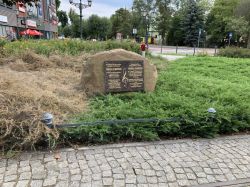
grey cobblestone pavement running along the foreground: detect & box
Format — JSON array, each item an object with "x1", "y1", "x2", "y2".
[{"x1": 0, "y1": 135, "x2": 250, "y2": 187}]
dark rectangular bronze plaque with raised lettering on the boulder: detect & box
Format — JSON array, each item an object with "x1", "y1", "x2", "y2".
[{"x1": 104, "y1": 61, "x2": 144, "y2": 93}]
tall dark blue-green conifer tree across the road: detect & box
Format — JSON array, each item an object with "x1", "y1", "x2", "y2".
[{"x1": 182, "y1": 0, "x2": 204, "y2": 46}]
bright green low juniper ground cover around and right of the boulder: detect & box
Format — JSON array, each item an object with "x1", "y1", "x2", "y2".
[{"x1": 61, "y1": 57, "x2": 250, "y2": 143}]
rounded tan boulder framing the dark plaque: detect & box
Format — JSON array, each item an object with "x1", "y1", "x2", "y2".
[{"x1": 81, "y1": 49, "x2": 157, "y2": 95}]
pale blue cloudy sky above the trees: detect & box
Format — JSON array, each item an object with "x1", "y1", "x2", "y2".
[{"x1": 59, "y1": 0, "x2": 133, "y2": 18}]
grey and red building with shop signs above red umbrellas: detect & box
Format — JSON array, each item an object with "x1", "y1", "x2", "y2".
[{"x1": 0, "y1": 0, "x2": 58, "y2": 39}]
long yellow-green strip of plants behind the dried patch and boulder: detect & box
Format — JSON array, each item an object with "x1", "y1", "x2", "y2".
[{"x1": 4, "y1": 40, "x2": 140, "y2": 56}]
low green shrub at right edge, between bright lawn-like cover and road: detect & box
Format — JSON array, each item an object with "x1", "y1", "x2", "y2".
[{"x1": 219, "y1": 47, "x2": 250, "y2": 58}]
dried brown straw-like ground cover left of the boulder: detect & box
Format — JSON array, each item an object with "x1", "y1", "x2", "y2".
[{"x1": 0, "y1": 52, "x2": 87, "y2": 150}]
